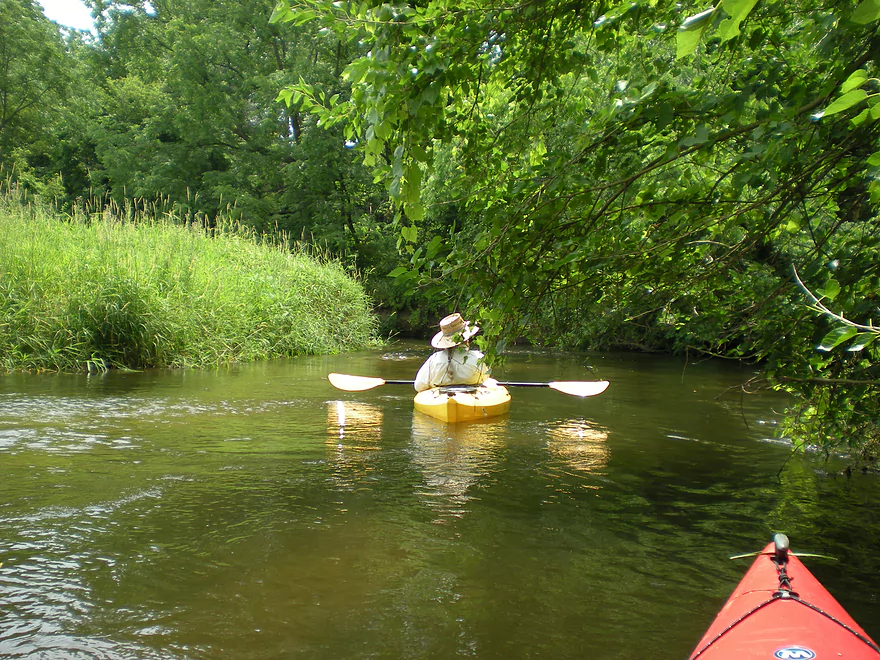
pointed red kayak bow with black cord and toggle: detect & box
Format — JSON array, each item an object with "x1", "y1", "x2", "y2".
[{"x1": 690, "y1": 534, "x2": 880, "y2": 660}]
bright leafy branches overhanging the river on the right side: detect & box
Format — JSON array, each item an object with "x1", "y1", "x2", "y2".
[{"x1": 275, "y1": 0, "x2": 880, "y2": 460}]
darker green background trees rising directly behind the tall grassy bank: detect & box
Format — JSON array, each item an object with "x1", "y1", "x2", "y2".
[{"x1": 0, "y1": 0, "x2": 420, "y2": 328}]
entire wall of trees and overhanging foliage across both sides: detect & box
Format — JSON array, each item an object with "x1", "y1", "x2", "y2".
[{"x1": 0, "y1": 0, "x2": 880, "y2": 461}]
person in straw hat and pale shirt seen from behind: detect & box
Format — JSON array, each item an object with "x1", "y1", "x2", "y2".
[{"x1": 413, "y1": 313, "x2": 491, "y2": 392}]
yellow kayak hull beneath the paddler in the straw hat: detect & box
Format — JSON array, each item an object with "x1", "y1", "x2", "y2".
[{"x1": 414, "y1": 385, "x2": 510, "y2": 422}]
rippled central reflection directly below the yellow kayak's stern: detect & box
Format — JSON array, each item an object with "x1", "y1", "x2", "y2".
[{"x1": 411, "y1": 413, "x2": 508, "y2": 523}]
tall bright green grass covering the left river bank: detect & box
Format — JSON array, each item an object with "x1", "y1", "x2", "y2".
[{"x1": 0, "y1": 191, "x2": 375, "y2": 371}]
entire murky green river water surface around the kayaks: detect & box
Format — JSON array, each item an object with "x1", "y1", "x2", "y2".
[{"x1": 0, "y1": 344, "x2": 880, "y2": 659}]
